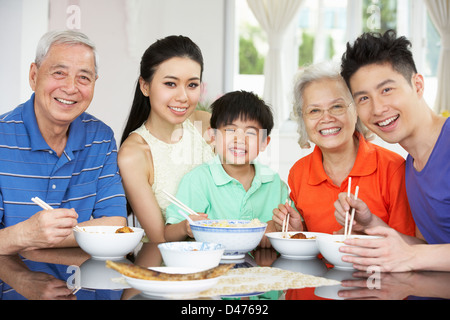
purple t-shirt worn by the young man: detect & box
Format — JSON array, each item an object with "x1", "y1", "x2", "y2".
[{"x1": 405, "y1": 118, "x2": 450, "y2": 244}]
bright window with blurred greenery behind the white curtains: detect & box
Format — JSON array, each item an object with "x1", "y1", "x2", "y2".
[{"x1": 233, "y1": 0, "x2": 441, "y2": 124}]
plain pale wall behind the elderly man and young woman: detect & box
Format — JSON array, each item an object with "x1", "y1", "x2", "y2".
[{"x1": 0, "y1": 0, "x2": 225, "y2": 144}]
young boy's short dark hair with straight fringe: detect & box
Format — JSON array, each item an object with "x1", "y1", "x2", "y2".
[{"x1": 210, "y1": 91, "x2": 274, "y2": 136}]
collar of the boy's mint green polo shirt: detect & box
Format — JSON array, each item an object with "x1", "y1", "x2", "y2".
[{"x1": 209, "y1": 155, "x2": 275, "y2": 186}]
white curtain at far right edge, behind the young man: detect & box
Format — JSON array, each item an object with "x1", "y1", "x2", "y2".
[{"x1": 424, "y1": 0, "x2": 450, "y2": 113}]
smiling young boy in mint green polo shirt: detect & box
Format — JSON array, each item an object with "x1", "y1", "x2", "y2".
[{"x1": 165, "y1": 91, "x2": 289, "y2": 247}]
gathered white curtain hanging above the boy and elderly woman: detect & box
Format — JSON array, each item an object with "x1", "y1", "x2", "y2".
[{"x1": 247, "y1": 0, "x2": 304, "y2": 126}]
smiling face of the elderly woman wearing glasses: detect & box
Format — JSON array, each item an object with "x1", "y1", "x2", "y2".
[{"x1": 302, "y1": 79, "x2": 357, "y2": 151}]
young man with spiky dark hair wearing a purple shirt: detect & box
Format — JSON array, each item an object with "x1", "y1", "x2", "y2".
[{"x1": 336, "y1": 30, "x2": 450, "y2": 271}]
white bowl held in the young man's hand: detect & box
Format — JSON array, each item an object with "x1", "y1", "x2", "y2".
[{"x1": 316, "y1": 234, "x2": 380, "y2": 270}]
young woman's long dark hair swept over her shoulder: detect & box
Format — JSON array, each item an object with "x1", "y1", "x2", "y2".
[{"x1": 120, "y1": 36, "x2": 203, "y2": 145}]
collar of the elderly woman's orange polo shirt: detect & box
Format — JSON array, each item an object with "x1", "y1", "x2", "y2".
[{"x1": 308, "y1": 133, "x2": 378, "y2": 185}]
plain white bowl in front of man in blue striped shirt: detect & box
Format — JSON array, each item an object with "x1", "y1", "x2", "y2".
[{"x1": 73, "y1": 226, "x2": 144, "y2": 260}]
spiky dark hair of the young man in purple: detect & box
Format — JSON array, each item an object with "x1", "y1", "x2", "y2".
[{"x1": 341, "y1": 30, "x2": 417, "y2": 89}]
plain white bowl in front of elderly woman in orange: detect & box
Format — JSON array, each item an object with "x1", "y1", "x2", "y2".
[{"x1": 266, "y1": 231, "x2": 322, "y2": 259}]
